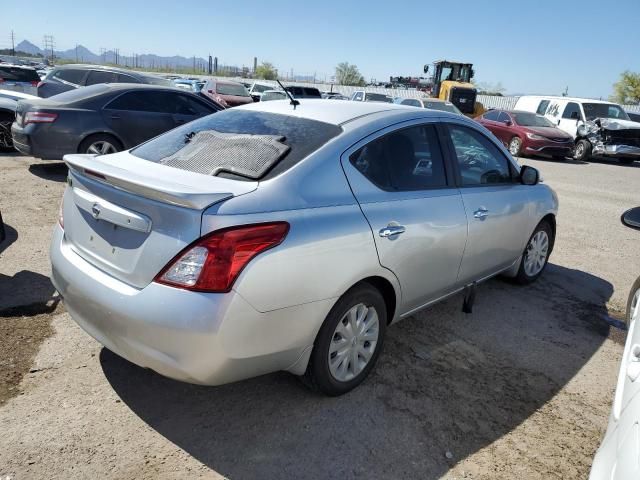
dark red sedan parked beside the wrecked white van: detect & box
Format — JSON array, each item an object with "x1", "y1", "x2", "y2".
[{"x1": 476, "y1": 110, "x2": 574, "y2": 160}]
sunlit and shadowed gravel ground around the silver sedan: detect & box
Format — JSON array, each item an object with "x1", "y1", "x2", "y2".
[{"x1": 0, "y1": 155, "x2": 640, "y2": 479}]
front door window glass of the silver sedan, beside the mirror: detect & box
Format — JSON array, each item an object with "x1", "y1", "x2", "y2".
[{"x1": 449, "y1": 125, "x2": 512, "y2": 187}]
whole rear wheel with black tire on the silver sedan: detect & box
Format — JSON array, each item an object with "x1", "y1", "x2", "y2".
[{"x1": 305, "y1": 283, "x2": 387, "y2": 396}]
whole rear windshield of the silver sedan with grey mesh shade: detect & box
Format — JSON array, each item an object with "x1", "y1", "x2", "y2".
[{"x1": 131, "y1": 109, "x2": 342, "y2": 180}]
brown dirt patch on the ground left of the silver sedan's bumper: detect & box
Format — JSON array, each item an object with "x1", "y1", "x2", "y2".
[{"x1": 0, "y1": 301, "x2": 63, "y2": 406}]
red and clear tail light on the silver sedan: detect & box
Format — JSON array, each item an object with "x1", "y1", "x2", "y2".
[{"x1": 154, "y1": 222, "x2": 289, "y2": 293}]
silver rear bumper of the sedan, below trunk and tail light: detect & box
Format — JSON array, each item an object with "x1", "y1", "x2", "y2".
[{"x1": 50, "y1": 226, "x2": 333, "y2": 385}]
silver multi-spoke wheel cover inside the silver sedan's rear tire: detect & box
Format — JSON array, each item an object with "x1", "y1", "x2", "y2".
[{"x1": 329, "y1": 303, "x2": 380, "y2": 382}]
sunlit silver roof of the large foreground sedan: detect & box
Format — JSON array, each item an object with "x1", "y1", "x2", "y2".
[{"x1": 235, "y1": 99, "x2": 432, "y2": 125}]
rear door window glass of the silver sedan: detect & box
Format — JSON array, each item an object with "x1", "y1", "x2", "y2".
[{"x1": 349, "y1": 125, "x2": 447, "y2": 192}]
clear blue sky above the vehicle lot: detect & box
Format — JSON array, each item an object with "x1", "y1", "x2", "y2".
[{"x1": 0, "y1": 0, "x2": 640, "y2": 97}]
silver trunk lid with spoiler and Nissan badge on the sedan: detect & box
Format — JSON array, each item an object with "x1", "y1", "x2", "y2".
[{"x1": 63, "y1": 152, "x2": 257, "y2": 288}]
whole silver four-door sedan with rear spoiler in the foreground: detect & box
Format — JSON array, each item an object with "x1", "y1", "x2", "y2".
[{"x1": 51, "y1": 100, "x2": 558, "y2": 395}]
